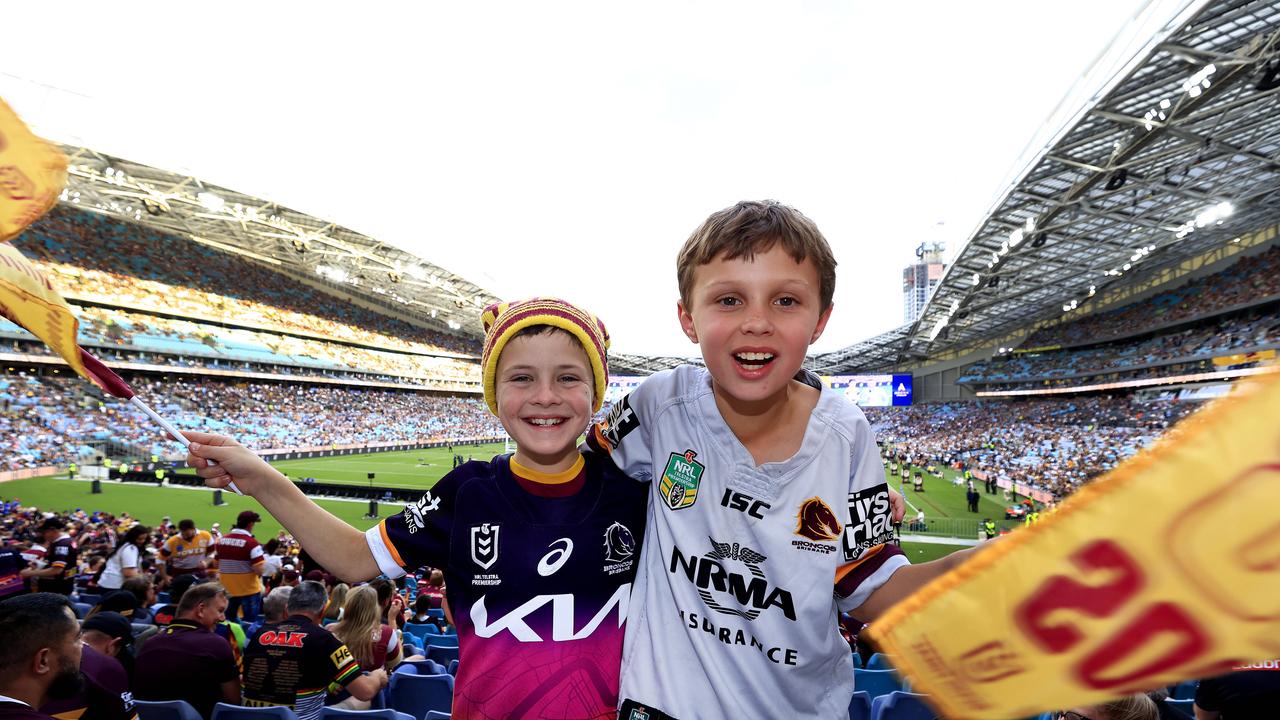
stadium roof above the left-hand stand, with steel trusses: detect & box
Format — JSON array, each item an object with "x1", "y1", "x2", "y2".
[{"x1": 61, "y1": 145, "x2": 497, "y2": 338}]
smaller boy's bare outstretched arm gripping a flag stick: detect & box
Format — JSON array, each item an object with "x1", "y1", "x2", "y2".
[{"x1": 183, "y1": 430, "x2": 380, "y2": 580}]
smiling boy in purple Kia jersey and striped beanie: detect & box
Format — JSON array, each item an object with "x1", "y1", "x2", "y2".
[{"x1": 187, "y1": 299, "x2": 648, "y2": 719}]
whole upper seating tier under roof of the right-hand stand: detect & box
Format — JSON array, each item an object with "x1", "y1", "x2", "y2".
[{"x1": 957, "y1": 240, "x2": 1280, "y2": 387}]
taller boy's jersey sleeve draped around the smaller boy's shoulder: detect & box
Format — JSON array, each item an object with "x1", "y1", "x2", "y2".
[{"x1": 586, "y1": 372, "x2": 673, "y2": 482}]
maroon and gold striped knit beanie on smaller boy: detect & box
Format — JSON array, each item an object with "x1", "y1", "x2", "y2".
[{"x1": 480, "y1": 297, "x2": 609, "y2": 415}]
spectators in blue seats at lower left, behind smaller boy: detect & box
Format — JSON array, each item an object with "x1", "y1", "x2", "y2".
[{"x1": 0, "y1": 498, "x2": 458, "y2": 720}]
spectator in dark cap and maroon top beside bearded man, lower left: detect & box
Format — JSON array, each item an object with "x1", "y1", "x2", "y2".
[{"x1": 40, "y1": 612, "x2": 138, "y2": 720}]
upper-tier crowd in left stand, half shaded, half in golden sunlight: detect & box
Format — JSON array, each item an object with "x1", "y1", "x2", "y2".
[{"x1": 14, "y1": 209, "x2": 480, "y2": 355}]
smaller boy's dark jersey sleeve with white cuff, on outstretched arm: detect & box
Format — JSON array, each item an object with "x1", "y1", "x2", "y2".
[{"x1": 365, "y1": 464, "x2": 458, "y2": 578}]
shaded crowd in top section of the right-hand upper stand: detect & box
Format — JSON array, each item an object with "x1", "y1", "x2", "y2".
[{"x1": 1023, "y1": 245, "x2": 1280, "y2": 348}]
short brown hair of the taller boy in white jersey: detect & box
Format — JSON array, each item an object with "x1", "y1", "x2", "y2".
[{"x1": 676, "y1": 200, "x2": 836, "y2": 311}]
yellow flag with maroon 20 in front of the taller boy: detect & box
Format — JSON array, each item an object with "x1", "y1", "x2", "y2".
[{"x1": 870, "y1": 374, "x2": 1280, "y2": 720}]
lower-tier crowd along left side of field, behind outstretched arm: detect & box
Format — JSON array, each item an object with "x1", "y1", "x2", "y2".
[{"x1": 0, "y1": 373, "x2": 504, "y2": 471}]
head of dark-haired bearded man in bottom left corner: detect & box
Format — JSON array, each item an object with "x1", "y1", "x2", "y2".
[{"x1": 0, "y1": 593, "x2": 83, "y2": 720}]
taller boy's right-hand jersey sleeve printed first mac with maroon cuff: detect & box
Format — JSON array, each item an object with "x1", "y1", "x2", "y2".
[{"x1": 836, "y1": 411, "x2": 910, "y2": 611}]
